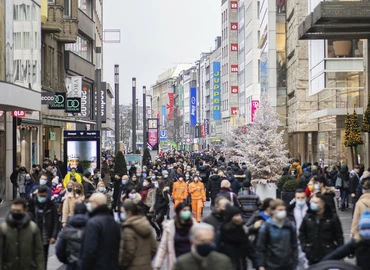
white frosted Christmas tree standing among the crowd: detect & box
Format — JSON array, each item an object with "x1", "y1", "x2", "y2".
[{"x1": 225, "y1": 92, "x2": 289, "y2": 184}]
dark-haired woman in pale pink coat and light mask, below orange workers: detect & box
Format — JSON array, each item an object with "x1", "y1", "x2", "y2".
[{"x1": 154, "y1": 202, "x2": 197, "y2": 270}]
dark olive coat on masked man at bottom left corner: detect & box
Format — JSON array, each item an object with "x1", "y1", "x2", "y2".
[{"x1": 0, "y1": 213, "x2": 45, "y2": 270}]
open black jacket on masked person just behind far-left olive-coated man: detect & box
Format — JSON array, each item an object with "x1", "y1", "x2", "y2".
[{"x1": 28, "y1": 196, "x2": 59, "y2": 239}]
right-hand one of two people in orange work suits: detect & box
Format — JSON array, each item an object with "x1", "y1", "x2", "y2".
[{"x1": 189, "y1": 175, "x2": 206, "y2": 222}]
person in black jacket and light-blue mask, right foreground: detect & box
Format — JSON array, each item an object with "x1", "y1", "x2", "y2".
[{"x1": 299, "y1": 194, "x2": 344, "y2": 265}]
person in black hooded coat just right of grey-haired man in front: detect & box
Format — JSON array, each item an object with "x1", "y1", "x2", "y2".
[{"x1": 217, "y1": 206, "x2": 256, "y2": 270}]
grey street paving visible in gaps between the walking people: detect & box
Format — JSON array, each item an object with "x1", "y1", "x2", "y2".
[{"x1": 0, "y1": 199, "x2": 354, "y2": 270}]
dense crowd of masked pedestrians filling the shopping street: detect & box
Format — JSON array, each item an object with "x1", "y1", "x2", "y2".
[{"x1": 0, "y1": 151, "x2": 370, "y2": 270}]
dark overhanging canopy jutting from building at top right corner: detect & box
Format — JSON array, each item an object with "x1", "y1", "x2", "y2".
[{"x1": 298, "y1": 1, "x2": 370, "y2": 40}]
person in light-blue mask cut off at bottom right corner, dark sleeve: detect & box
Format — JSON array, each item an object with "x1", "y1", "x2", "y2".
[{"x1": 322, "y1": 210, "x2": 370, "y2": 270}]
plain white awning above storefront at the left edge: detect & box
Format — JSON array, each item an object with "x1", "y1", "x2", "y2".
[{"x1": 0, "y1": 81, "x2": 41, "y2": 111}]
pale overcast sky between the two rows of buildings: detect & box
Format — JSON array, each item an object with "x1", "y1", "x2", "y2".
[{"x1": 103, "y1": 0, "x2": 221, "y2": 104}]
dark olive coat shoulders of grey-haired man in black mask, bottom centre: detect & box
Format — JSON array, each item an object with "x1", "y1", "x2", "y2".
[{"x1": 173, "y1": 251, "x2": 233, "y2": 270}]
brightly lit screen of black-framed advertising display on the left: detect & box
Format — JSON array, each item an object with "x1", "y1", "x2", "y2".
[{"x1": 66, "y1": 140, "x2": 98, "y2": 174}]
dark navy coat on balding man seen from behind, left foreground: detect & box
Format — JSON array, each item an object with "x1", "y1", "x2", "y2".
[{"x1": 80, "y1": 205, "x2": 120, "y2": 270}]
